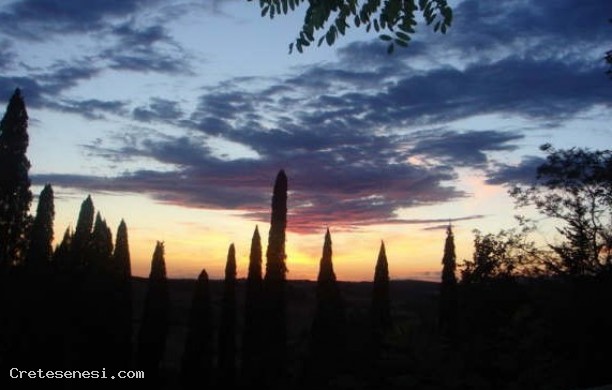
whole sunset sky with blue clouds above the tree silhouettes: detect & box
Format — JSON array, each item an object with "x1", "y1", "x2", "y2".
[{"x1": 0, "y1": 0, "x2": 612, "y2": 280}]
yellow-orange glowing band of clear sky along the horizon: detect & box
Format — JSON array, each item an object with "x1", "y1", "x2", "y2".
[{"x1": 44, "y1": 176, "x2": 492, "y2": 281}]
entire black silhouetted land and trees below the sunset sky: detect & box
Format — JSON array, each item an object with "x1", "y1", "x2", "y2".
[{"x1": 0, "y1": 90, "x2": 612, "y2": 389}]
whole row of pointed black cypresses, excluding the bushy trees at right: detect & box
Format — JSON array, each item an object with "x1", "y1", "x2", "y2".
[{"x1": 0, "y1": 89, "x2": 456, "y2": 389}]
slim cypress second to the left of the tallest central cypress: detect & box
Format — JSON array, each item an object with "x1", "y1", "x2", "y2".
[{"x1": 218, "y1": 244, "x2": 236, "y2": 389}]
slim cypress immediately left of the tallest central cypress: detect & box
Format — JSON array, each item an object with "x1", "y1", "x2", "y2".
[{"x1": 242, "y1": 226, "x2": 263, "y2": 388}]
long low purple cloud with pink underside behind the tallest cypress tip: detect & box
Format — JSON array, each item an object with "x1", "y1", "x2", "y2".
[{"x1": 35, "y1": 133, "x2": 464, "y2": 231}]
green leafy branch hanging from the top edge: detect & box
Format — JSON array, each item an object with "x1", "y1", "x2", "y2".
[{"x1": 247, "y1": 0, "x2": 453, "y2": 53}]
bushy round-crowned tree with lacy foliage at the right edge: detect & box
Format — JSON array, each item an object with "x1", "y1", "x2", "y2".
[{"x1": 511, "y1": 144, "x2": 612, "y2": 276}]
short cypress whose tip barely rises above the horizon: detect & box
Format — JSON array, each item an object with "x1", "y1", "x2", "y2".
[{"x1": 181, "y1": 269, "x2": 214, "y2": 389}]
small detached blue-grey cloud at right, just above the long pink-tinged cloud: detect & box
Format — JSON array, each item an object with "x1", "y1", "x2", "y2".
[{"x1": 411, "y1": 130, "x2": 524, "y2": 167}]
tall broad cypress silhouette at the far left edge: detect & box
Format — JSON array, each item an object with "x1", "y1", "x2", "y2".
[{"x1": 0, "y1": 88, "x2": 32, "y2": 270}]
